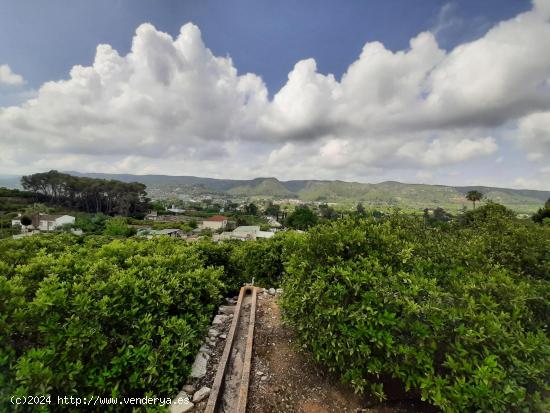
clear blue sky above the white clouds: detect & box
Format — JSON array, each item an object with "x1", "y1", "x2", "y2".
[{"x1": 0, "y1": 0, "x2": 531, "y2": 91}]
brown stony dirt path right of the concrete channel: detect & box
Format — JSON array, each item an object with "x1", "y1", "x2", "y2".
[{"x1": 247, "y1": 293, "x2": 433, "y2": 413}]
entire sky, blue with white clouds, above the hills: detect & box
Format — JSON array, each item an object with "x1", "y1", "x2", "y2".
[{"x1": 0, "y1": 0, "x2": 550, "y2": 190}]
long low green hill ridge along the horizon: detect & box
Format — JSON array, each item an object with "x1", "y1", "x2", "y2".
[{"x1": 5, "y1": 171, "x2": 550, "y2": 213}]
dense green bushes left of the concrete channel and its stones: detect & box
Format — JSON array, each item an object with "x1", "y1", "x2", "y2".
[{"x1": 0, "y1": 234, "x2": 223, "y2": 411}]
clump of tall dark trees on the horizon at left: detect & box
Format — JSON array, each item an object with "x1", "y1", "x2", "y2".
[{"x1": 21, "y1": 171, "x2": 149, "y2": 215}]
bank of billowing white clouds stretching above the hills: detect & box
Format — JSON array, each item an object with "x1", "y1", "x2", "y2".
[{"x1": 0, "y1": 0, "x2": 550, "y2": 187}]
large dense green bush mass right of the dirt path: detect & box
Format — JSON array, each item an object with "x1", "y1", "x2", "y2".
[{"x1": 282, "y1": 204, "x2": 550, "y2": 412}]
